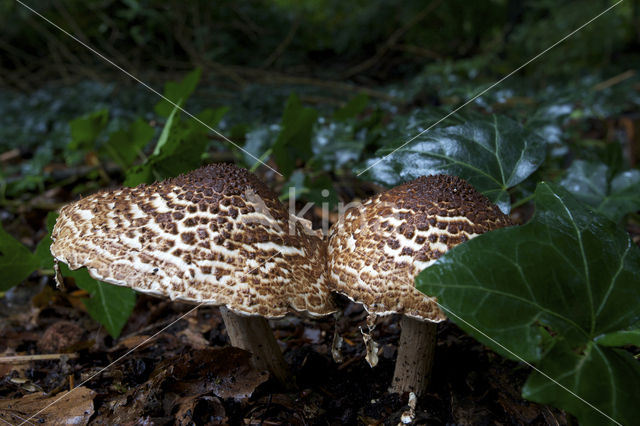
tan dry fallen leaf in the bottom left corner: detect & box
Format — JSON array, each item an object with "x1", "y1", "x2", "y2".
[{"x1": 0, "y1": 387, "x2": 96, "y2": 425}]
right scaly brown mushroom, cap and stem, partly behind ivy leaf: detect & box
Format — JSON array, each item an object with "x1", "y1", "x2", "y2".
[{"x1": 327, "y1": 175, "x2": 511, "y2": 395}]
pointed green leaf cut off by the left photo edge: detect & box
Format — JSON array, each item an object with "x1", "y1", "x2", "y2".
[{"x1": 0, "y1": 225, "x2": 38, "y2": 291}]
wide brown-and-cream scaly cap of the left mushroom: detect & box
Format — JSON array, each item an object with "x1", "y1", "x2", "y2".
[{"x1": 51, "y1": 164, "x2": 335, "y2": 318}]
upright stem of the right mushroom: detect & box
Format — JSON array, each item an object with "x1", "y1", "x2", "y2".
[{"x1": 391, "y1": 315, "x2": 438, "y2": 396}]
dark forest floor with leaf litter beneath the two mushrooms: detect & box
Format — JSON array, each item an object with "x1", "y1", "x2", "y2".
[{"x1": 0, "y1": 279, "x2": 567, "y2": 425}]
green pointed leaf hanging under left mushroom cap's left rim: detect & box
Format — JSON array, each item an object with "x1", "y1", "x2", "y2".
[{"x1": 60, "y1": 264, "x2": 136, "y2": 338}]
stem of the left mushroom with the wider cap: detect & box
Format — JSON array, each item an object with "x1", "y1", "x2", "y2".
[{"x1": 220, "y1": 306, "x2": 291, "y2": 386}]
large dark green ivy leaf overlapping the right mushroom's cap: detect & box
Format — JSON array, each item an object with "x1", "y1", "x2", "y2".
[{"x1": 416, "y1": 183, "x2": 640, "y2": 425}]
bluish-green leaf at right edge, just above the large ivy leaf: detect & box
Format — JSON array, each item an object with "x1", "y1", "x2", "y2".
[{"x1": 560, "y1": 160, "x2": 640, "y2": 222}]
